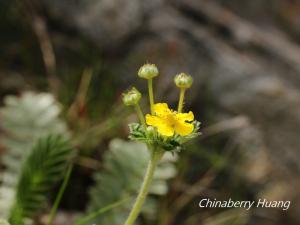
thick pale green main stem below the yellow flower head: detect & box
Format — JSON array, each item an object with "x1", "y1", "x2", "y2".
[{"x1": 124, "y1": 149, "x2": 162, "y2": 225}]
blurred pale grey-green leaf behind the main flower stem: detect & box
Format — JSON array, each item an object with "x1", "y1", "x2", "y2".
[{"x1": 87, "y1": 139, "x2": 176, "y2": 225}]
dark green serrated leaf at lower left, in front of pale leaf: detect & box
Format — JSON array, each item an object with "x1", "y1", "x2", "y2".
[{"x1": 9, "y1": 135, "x2": 71, "y2": 225}]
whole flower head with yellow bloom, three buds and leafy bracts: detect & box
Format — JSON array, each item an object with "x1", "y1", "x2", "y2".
[{"x1": 123, "y1": 64, "x2": 200, "y2": 151}]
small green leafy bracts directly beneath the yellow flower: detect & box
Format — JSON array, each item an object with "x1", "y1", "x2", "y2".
[{"x1": 129, "y1": 121, "x2": 200, "y2": 151}]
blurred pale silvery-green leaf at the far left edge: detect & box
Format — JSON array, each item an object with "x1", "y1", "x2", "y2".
[{"x1": 0, "y1": 92, "x2": 67, "y2": 219}]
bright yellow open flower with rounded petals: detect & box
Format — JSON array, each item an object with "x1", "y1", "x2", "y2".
[{"x1": 146, "y1": 103, "x2": 194, "y2": 137}]
